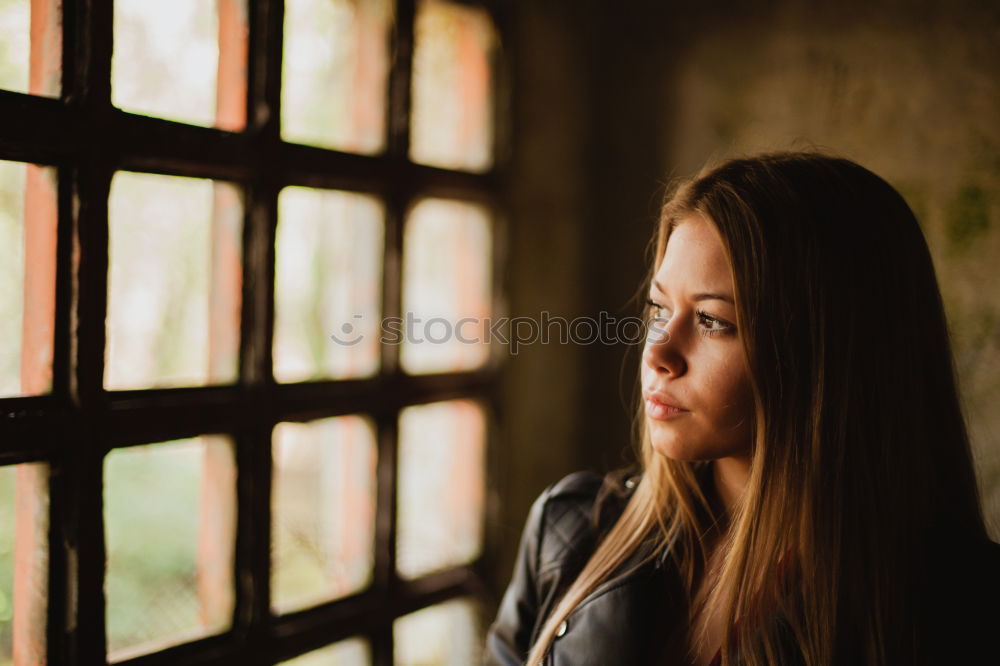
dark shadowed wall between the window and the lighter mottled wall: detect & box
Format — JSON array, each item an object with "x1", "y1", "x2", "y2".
[{"x1": 495, "y1": 0, "x2": 680, "y2": 582}]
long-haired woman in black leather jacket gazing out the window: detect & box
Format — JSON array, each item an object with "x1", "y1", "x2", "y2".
[{"x1": 486, "y1": 153, "x2": 1000, "y2": 666}]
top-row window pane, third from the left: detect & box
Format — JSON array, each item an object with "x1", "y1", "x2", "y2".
[{"x1": 281, "y1": 0, "x2": 392, "y2": 153}]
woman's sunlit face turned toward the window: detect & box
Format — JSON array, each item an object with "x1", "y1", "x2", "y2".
[{"x1": 642, "y1": 215, "x2": 753, "y2": 460}]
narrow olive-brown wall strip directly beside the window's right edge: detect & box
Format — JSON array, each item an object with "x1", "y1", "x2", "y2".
[{"x1": 493, "y1": 3, "x2": 590, "y2": 581}]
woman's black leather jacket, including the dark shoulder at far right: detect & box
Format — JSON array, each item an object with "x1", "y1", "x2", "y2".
[{"x1": 484, "y1": 472, "x2": 1000, "y2": 666}]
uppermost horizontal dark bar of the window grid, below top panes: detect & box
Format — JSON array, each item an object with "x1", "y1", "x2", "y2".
[{"x1": 0, "y1": 102, "x2": 498, "y2": 204}]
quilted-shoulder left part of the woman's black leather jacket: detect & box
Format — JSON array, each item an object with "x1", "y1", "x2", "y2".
[{"x1": 485, "y1": 472, "x2": 683, "y2": 666}]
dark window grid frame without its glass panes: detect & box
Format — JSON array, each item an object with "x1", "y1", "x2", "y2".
[{"x1": 0, "y1": 0, "x2": 509, "y2": 666}]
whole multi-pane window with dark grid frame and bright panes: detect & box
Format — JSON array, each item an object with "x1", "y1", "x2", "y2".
[{"x1": 0, "y1": 0, "x2": 503, "y2": 666}]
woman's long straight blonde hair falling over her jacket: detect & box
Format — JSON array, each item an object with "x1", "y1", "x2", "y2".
[{"x1": 528, "y1": 153, "x2": 986, "y2": 666}]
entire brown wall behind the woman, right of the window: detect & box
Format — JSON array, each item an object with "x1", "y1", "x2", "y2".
[{"x1": 497, "y1": 0, "x2": 1000, "y2": 592}]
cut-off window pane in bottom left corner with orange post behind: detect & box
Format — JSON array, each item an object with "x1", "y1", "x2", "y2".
[{"x1": 0, "y1": 463, "x2": 49, "y2": 664}]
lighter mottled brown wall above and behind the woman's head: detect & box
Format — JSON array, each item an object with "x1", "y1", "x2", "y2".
[{"x1": 662, "y1": 2, "x2": 1000, "y2": 538}]
